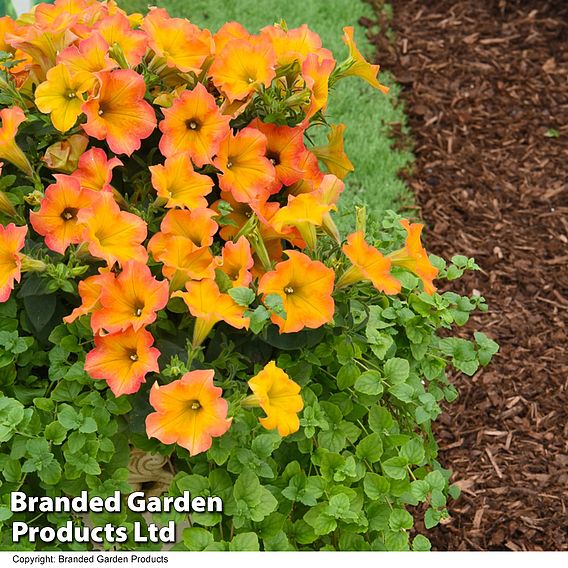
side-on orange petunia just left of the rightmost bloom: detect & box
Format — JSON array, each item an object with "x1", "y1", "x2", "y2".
[{"x1": 337, "y1": 231, "x2": 401, "y2": 295}]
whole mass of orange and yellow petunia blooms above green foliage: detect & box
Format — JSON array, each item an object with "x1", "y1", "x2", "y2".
[{"x1": 0, "y1": 0, "x2": 437, "y2": 455}]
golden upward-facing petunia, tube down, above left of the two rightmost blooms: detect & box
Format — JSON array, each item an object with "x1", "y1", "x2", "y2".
[{"x1": 271, "y1": 193, "x2": 332, "y2": 250}]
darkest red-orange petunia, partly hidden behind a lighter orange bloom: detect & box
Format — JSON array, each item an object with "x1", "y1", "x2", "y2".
[{"x1": 250, "y1": 118, "x2": 306, "y2": 193}]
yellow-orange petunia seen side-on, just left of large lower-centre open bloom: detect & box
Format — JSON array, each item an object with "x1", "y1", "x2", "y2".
[{"x1": 172, "y1": 279, "x2": 249, "y2": 347}]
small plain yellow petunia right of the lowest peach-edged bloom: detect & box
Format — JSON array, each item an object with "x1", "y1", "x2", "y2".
[{"x1": 248, "y1": 361, "x2": 304, "y2": 436}]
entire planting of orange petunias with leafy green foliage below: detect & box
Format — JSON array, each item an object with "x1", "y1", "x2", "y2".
[{"x1": 0, "y1": 0, "x2": 497, "y2": 550}]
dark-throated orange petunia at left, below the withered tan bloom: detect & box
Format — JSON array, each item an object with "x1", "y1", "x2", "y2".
[{"x1": 30, "y1": 174, "x2": 93, "y2": 254}]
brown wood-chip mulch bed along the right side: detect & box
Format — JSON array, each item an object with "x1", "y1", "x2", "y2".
[{"x1": 362, "y1": 0, "x2": 568, "y2": 550}]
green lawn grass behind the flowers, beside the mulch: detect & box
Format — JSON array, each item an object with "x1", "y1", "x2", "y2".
[{"x1": 120, "y1": 0, "x2": 412, "y2": 228}]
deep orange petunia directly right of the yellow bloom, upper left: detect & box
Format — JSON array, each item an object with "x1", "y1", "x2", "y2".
[{"x1": 82, "y1": 69, "x2": 156, "y2": 156}]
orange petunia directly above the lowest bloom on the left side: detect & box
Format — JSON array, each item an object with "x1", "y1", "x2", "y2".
[{"x1": 91, "y1": 261, "x2": 169, "y2": 333}]
